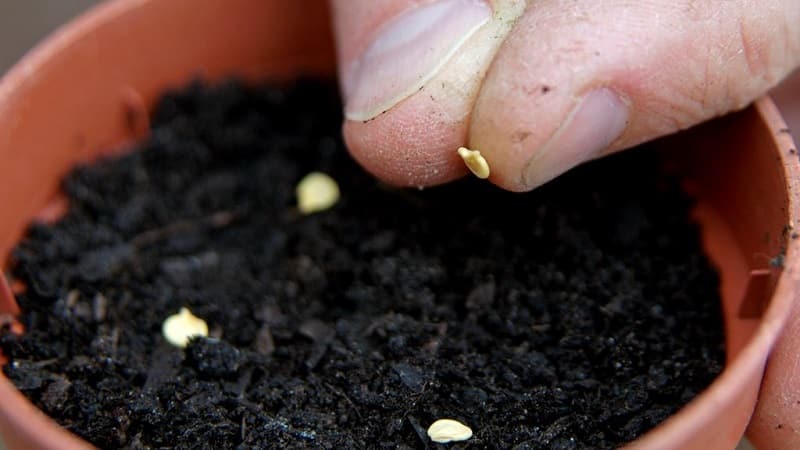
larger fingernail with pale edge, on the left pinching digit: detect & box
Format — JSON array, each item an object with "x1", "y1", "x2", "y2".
[{"x1": 343, "y1": 0, "x2": 492, "y2": 121}]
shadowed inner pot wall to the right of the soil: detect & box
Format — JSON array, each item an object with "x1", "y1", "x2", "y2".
[{"x1": 659, "y1": 105, "x2": 794, "y2": 362}]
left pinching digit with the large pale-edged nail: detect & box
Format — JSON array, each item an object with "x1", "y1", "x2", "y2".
[{"x1": 331, "y1": 0, "x2": 526, "y2": 186}]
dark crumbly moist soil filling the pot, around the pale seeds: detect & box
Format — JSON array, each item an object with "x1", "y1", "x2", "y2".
[{"x1": 2, "y1": 82, "x2": 724, "y2": 449}]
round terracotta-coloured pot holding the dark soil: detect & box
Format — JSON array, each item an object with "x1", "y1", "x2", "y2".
[{"x1": 0, "y1": 0, "x2": 800, "y2": 450}]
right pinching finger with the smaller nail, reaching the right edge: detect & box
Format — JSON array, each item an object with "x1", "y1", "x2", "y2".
[{"x1": 469, "y1": 0, "x2": 800, "y2": 190}]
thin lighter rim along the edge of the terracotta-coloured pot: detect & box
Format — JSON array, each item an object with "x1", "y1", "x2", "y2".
[{"x1": 0, "y1": 0, "x2": 800, "y2": 449}]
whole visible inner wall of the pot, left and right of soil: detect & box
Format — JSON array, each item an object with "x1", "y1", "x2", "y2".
[{"x1": 0, "y1": 0, "x2": 789, "y2": 448}]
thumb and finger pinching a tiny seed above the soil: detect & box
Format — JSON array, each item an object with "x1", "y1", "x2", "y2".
[{"x1": 331, "y1": 0, "x2": 800, "y2": 191}]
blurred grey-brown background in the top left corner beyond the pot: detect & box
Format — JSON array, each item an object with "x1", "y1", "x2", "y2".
[{"x1": 0, "y1": 0, "x2": 101, "y2": 74}]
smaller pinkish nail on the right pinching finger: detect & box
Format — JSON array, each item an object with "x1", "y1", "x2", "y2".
[{"x1": 524, "y1": 88, "x2": 629, "y2": 189}]
